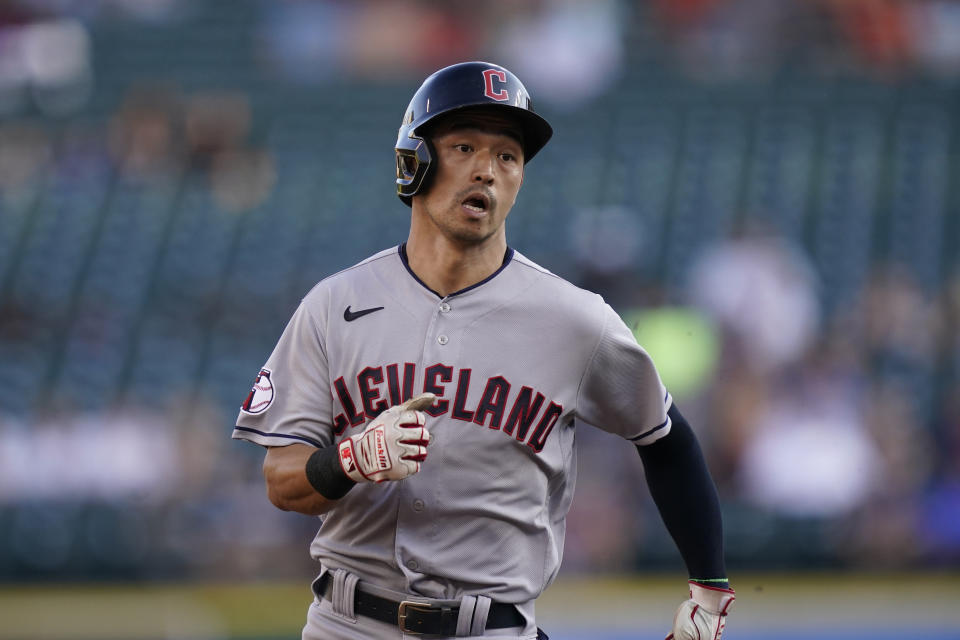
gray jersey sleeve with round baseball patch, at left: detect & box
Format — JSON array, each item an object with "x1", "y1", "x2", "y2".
[{"x1": 233, "y1": 300, "x2": 333, "y2": 447}]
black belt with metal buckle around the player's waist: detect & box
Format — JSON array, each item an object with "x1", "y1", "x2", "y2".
[{"x1": 317, "y1": 573, "x2": 526, "y2": 636}]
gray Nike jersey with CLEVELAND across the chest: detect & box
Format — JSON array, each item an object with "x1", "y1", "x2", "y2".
[{"x1": 233, "y1": 247, "x2": 671, "y2": 603}]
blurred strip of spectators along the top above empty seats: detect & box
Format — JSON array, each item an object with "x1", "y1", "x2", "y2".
[{"x1": 0, "y1": 0, "x2": 960, "y2": 114}]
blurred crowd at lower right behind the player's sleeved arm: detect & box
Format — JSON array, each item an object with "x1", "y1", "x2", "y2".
[{"x1": 573, "y1": 229, "x2": 960, "y2": 570}]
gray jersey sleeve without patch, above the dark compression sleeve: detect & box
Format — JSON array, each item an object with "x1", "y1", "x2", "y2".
[{"x1": 577, "y1": 303, "x2": 673, "y2": 445}]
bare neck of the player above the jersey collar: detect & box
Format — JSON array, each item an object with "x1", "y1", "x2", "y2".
[{"x1": 407, "y1": 234, "x2": 507, "y2": 296}]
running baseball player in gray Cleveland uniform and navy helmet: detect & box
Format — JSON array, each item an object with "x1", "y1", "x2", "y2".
[{"x1": 233, "y1": 62, "x2": 734, "y2": 640}]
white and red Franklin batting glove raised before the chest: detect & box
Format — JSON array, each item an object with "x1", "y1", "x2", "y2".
[{"x1": 337, "y1": 393, "x2": 437, "y2": 482}]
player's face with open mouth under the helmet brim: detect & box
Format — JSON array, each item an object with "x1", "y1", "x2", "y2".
[{"x1": 414, "y1": 114, "x2": 523, "y2": 246}]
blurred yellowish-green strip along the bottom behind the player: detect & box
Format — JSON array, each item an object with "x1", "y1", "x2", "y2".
[{"x1": 0, "y1": 573, "x2": 960, "y2": 640}]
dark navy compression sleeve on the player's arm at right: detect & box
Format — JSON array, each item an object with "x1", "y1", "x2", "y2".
[{"x1": 637, "y1": 405, "x2": 727, "y2": 586}]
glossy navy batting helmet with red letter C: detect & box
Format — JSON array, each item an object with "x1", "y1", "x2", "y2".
[{"x1": 395, "y1": 62, "x2": 553, "y2": 205}]
